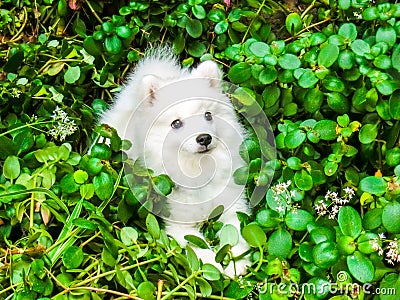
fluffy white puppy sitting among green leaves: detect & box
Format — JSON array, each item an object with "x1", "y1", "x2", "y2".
[{"x1": 100, "y1": 47, "x2": 249, "y2": 277}]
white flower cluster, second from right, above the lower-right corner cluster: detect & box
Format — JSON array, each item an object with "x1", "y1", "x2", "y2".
[{"x1": 315, "y1": 187, "x2": 355, "y2": 219}]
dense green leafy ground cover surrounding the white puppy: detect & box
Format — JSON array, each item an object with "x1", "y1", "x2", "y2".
[{"x1": 0, "y1": 0, "x2": 400, "y2": 300}]
